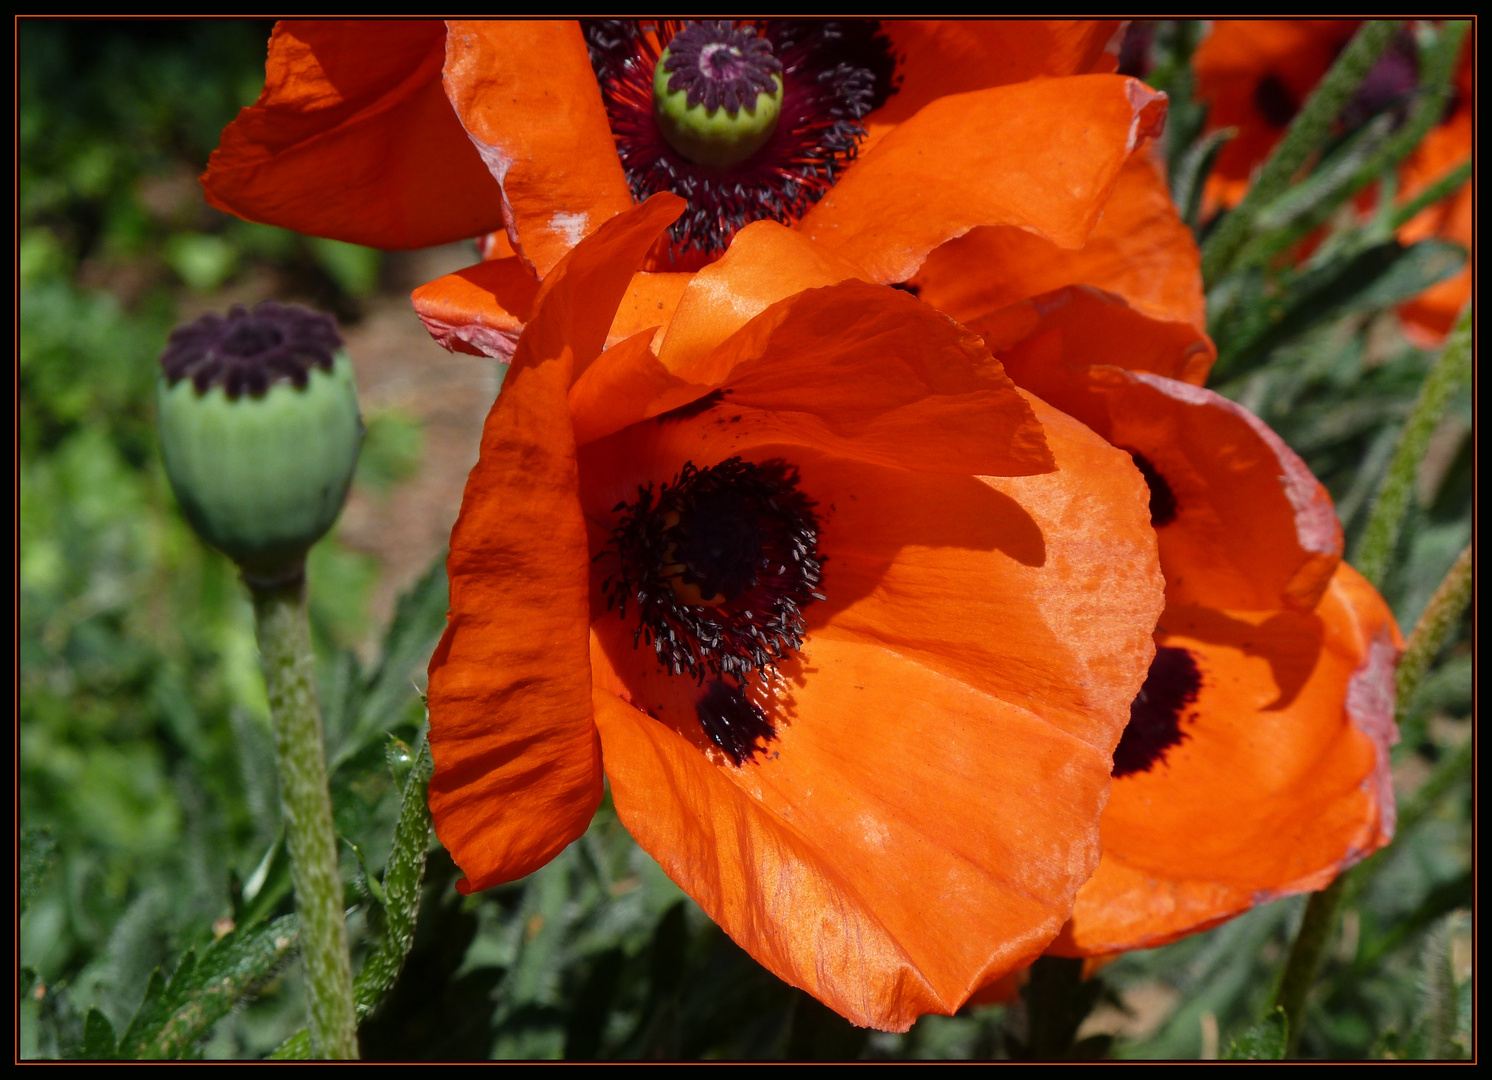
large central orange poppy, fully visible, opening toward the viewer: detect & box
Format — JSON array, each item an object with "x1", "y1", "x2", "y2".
[{"x1": 430, "y1": 195, "x2": 1161, "y2": 1029}]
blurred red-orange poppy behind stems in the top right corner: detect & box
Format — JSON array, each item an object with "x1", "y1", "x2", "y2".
[{"x1": 1194, "y1": 19, "x2": 1476, "y2": 348}]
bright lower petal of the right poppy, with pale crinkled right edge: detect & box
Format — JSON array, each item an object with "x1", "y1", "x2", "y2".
[{"x1": 1053, "y1": 564, "x2": 1402, "y2": 955}]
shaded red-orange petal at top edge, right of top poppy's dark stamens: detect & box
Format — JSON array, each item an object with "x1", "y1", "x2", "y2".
[{"x1": 862, "y1": 19, "x2": 1122, "y2": 149}]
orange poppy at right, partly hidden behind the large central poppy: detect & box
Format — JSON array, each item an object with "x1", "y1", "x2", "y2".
[{"x1": 970, "y1": 286, "x2": 1402, "y2": 956}]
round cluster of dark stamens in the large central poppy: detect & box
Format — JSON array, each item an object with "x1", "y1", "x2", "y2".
[{"x1": 601, "y1": 458, "x2": 824, "y2": 683}]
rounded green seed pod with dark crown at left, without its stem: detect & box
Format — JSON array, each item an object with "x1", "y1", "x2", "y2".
[{"x1": 157, "y1": 301, "x2": 363, "y2": 586}]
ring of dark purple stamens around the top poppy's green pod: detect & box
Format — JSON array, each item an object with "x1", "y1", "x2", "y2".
[{"x1": 583, "y1": 19, "x2": 895, "y2": 258}]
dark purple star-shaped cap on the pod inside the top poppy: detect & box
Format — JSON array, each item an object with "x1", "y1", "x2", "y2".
[{"x1": 662, "y1": 19, "x2": 782, "y2": 115}]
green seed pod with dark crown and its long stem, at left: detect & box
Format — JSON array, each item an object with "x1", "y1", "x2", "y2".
[{"x1": 157, "y1": 301, "x2": 363, "y2": 1058}]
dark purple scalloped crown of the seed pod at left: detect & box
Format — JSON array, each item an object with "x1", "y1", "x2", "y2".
[{"x1": 161, "y1": 300, "x2": 342, "y2": 398}]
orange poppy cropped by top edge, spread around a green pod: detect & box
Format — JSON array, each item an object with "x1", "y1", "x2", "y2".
[{"x1": 203, "y1": 21, "x2": 1181, "y2": 360}]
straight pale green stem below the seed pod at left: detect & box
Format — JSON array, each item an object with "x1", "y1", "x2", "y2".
[{"x1": 249, "y1": 576, "x2": 358, "y2": 1059}]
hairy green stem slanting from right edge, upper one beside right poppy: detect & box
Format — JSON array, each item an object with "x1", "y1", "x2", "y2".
[{"x1": 1352, "y1": 304, "x2": 1471, "y2": 585}]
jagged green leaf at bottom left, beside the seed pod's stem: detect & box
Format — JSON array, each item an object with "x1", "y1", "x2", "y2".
[{"x1": 119, "y1": 914, "x2": 297, "y2": 1059}]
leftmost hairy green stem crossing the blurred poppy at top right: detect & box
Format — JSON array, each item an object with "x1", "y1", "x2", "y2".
[{"x1": 1203, "y1": 19, "x2": 1399, "y2": 288}]
